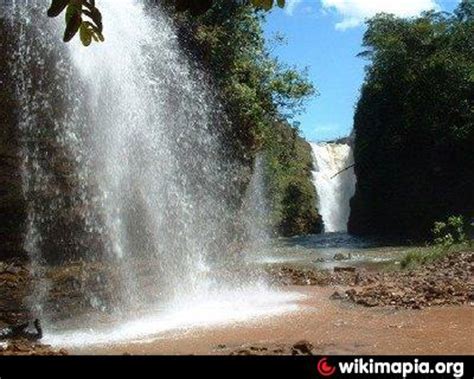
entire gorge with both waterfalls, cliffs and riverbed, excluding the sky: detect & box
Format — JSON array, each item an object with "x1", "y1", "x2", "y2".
[{"x1": 0, "y1": 0, "x2": 474, "y2": 355}]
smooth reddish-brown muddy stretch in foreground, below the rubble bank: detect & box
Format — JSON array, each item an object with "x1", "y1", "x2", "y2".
[{"x1": 70, "y1": 286, "x2": 474, "y2": 355}]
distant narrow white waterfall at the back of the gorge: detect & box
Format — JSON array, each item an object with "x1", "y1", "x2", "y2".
[{"x1": 311, "y1": 142, "x2": 356, "y2": 233}]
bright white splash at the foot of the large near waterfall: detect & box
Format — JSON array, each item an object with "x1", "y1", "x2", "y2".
[{"x1": 42, "y1": 288, "x2": 304, "y2": 348}]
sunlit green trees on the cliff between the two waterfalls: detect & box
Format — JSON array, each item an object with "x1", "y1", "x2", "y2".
[{"x1": 170, "y1": 1, "x2": 321, "y2": 235}]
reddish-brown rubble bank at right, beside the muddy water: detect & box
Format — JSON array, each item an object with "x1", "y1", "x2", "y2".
[{"x1": 269, "y1": 252, "x2": 474, "y2": 309}]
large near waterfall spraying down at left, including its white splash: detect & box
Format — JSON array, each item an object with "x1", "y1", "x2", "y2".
[{"x1": 2, "y1": 0, "x2": 300, "y2": 344}]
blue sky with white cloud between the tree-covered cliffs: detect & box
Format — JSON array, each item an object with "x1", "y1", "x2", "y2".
[{"x1": 265, "y1": 0, "x2": 458, "y2": 141}]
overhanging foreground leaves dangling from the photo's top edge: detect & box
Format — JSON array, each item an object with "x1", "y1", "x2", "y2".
[{"x1": 48, "y1": 0, "x2": 285, "y2": 46}]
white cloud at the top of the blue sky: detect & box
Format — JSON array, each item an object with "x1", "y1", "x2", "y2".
[{"x1": 321, "y1": 0, "x2": 440, "y2": 30}]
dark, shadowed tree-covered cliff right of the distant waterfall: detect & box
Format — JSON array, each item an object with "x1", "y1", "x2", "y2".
[{"x1": 349, "y1": 1, "x2": 474, "y2": 238}]
